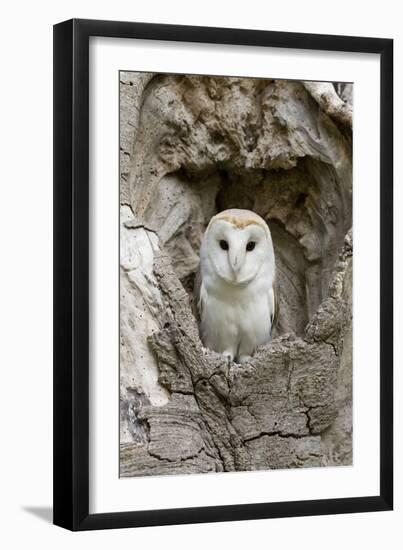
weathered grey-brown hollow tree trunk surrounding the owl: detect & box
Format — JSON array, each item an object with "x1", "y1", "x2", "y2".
[{"x1": 120, "y1": 72, "x2": 352, "y2": 476}]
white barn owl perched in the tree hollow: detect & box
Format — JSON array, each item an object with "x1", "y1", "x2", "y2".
[{"x1": 195, "y1": 209, "x2": 278, "y2": 363}]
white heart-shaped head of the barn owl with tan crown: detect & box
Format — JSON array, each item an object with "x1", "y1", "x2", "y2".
[{"x1": 200, "y1": 208, "x2": 275, "y2": 285}]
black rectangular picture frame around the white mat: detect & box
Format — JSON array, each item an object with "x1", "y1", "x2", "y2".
[{"x1": 54, "y1": 19, "x2": 393, "y2": 530}]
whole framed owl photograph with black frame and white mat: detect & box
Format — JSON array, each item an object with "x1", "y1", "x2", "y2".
[{"x1": 54, "y1": 20, "x2": 393, "y2": 530}]
